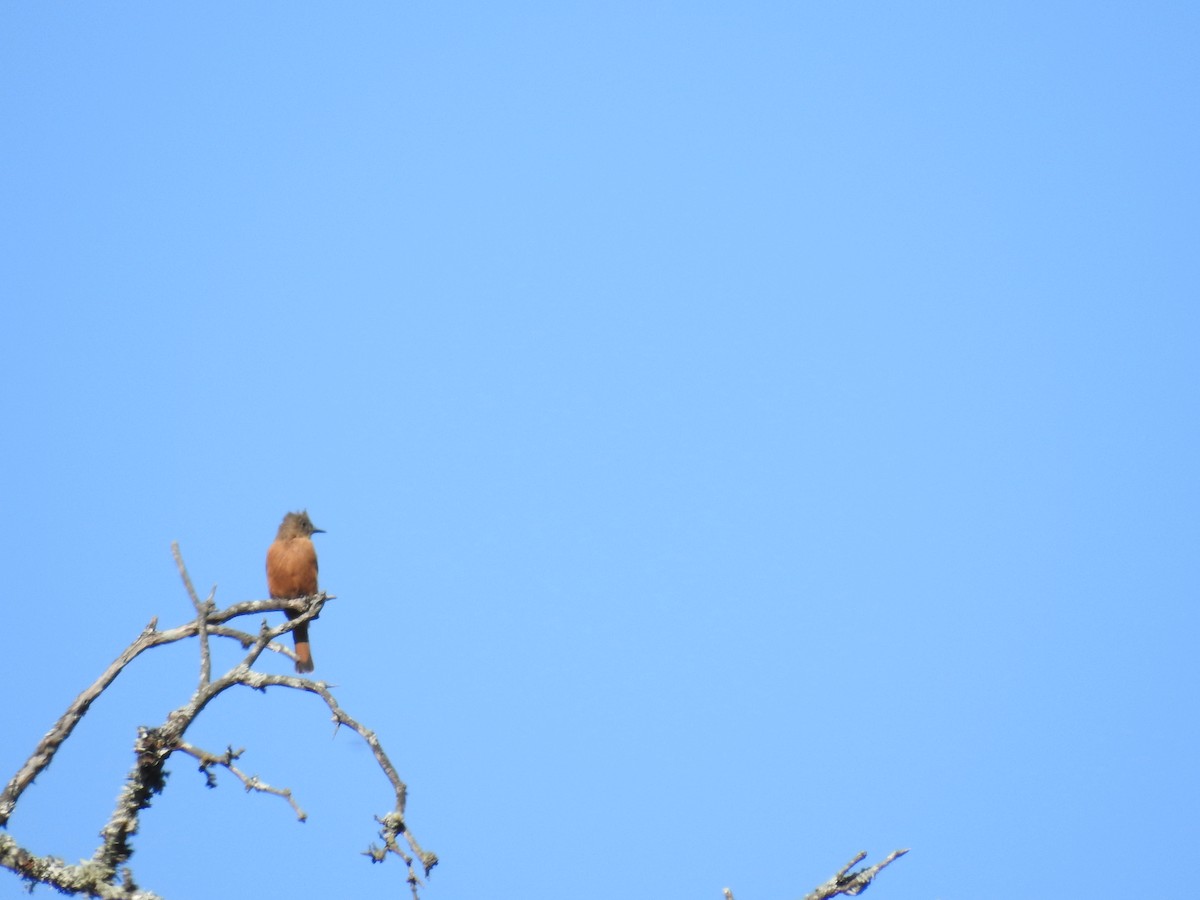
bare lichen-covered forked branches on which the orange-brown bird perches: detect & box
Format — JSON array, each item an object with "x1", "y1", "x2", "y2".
[{"x1": 0, "y1": 544, "x2": 438, "y2": 900}]
